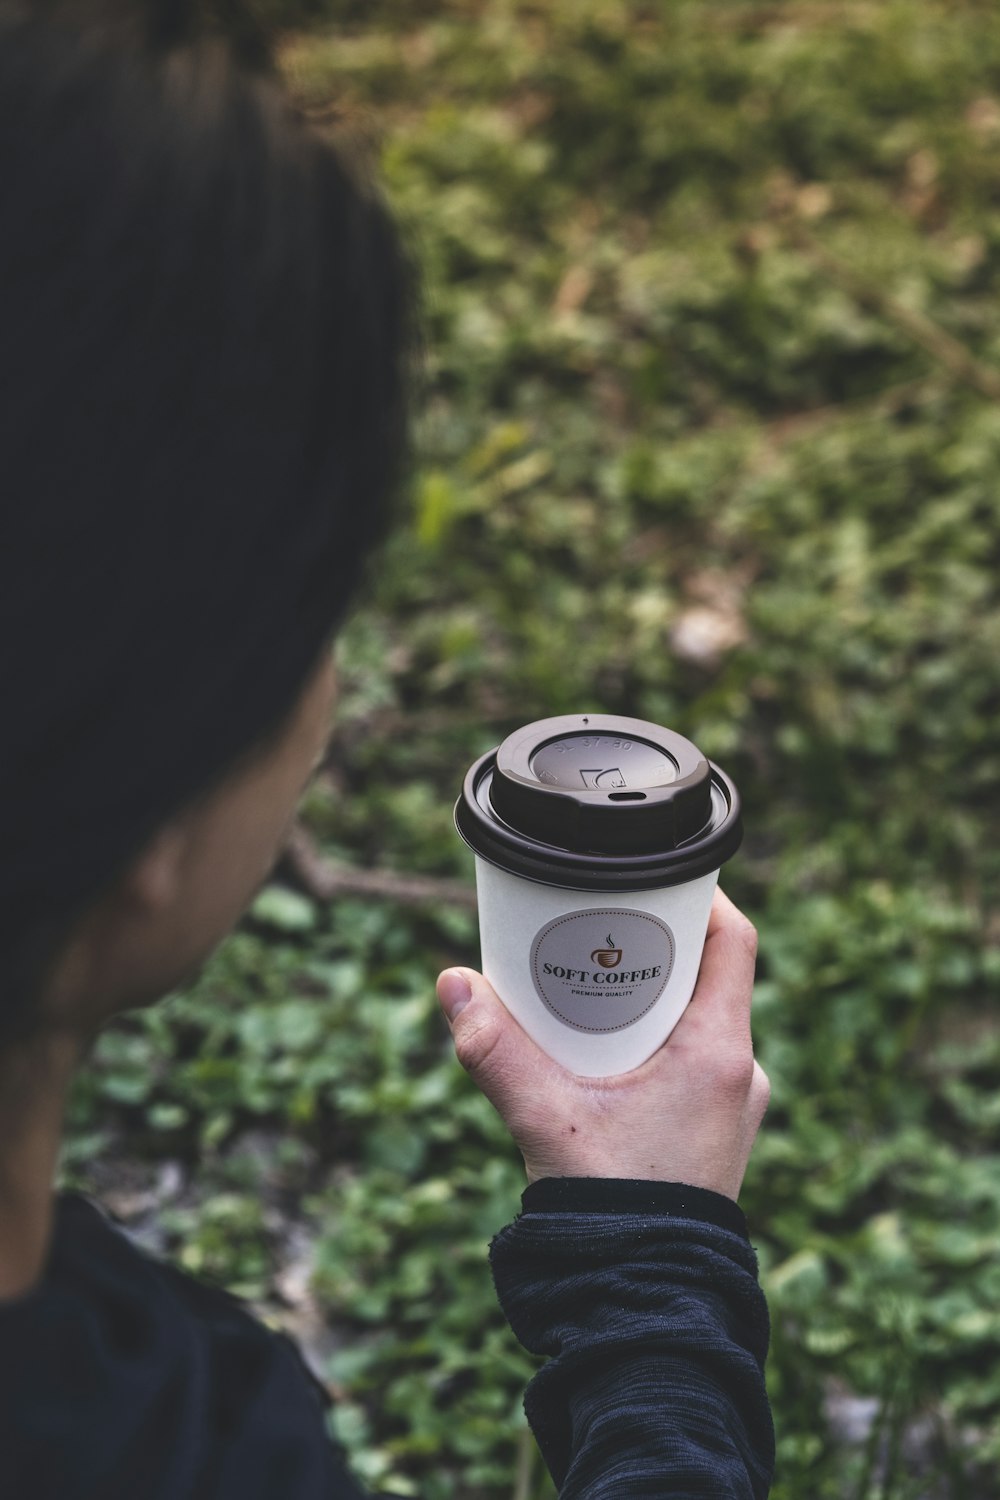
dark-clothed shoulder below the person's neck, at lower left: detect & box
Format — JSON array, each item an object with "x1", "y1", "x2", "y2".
[{"x1": 0, "y1": 1196, "x2": 340, "y2": 1500}]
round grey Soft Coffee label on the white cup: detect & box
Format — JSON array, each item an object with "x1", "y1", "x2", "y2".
[{"x1": 531, "y1": 908, "x2": 675, "y2": 1032}]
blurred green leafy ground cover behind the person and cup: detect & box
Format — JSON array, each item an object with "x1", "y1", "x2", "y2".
[{"x1": 64, "y1": 0, "x2": 1000, "y2": 1500}]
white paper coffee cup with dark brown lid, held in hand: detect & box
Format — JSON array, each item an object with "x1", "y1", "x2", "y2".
[{"x1": 454, "y1": 714, "x2": 742, "y2": 1079}]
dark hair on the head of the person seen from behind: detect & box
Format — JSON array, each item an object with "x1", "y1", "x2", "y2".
[{"x1": 0, "y1": 0, "x2": 411, "y2": 1031}]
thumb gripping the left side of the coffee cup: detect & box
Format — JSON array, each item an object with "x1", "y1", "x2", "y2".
[{"x1": 438, "y1": 969, "x2": 555, "y2": 1118}]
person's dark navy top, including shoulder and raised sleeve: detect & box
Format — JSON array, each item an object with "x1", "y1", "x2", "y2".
[{"x1": 0, "y1": 1179, "x2": 774, "y2": 1500}]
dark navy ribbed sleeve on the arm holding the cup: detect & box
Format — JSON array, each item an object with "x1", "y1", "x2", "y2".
[{"x1": 490, "y1": 1179, "x2": 774, "y2": 1500}]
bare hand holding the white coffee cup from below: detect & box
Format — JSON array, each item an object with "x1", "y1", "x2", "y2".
[{"x1": 438, "y1": 891, "x2": 771, "y2": 1200}]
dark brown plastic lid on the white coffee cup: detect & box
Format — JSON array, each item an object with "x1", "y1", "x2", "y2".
[{"x1": 454, "y1": 714, "x2": 742, "y2": 891}]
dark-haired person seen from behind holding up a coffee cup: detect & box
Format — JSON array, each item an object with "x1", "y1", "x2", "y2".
[{"x1": 0, "y1": 0, "x2": 774, "y2": 1500}]
